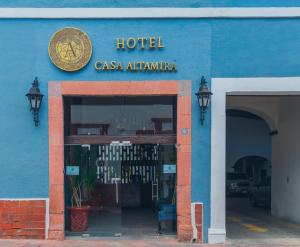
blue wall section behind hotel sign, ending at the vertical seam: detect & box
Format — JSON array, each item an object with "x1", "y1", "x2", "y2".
[{"x1": 0, "y1": 20, "x2": 211, "y2": 242}]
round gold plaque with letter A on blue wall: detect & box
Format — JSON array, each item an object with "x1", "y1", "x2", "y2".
[{"x1": 48, "y1": 27, "x2": 92, "y2": 71}]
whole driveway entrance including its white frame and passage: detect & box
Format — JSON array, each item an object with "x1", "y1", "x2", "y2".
[{"x1": 209, "y1": 78, "x2": 300, "y2": 245}]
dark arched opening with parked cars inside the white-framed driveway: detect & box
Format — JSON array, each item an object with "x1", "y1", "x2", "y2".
[{"x1": 226, "y1": 107, "x2": 274, "y2": 239}]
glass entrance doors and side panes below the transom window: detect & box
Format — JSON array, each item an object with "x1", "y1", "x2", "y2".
[{"x1": 65, "y1": 143, "x2": 176, "y2": 237}]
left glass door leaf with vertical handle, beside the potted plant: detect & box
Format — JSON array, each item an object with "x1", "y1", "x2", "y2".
[{"x1": 89, "y1": 145, "x2": 124, "y2": 236}]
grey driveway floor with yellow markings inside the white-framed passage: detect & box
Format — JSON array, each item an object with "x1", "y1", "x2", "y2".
[{"x1": 226, "y1": 197, "x2": 300, "y2": 246}]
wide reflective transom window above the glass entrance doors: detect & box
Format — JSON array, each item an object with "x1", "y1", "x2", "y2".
[{"x1": 64, "y1": 96, "x2": 176, "y2": 136}]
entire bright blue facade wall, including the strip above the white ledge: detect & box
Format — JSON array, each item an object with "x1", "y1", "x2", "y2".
[{"x1": 0, "y1": 0, "x2": 300, "y2": 242}]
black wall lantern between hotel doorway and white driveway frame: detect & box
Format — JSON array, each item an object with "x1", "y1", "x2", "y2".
[{"x1": 195, "y1": 76, "x2": 212, "y2": 125}]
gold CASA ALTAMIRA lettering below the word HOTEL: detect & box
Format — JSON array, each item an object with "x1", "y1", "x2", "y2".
[{"x1": 94, "y1": 60, "x2": 177, "y2": 72}]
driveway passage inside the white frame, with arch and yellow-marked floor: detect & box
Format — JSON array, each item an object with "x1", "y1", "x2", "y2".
[{"x1": 226, "y1": 95, "x2": 300, "y2": 245}]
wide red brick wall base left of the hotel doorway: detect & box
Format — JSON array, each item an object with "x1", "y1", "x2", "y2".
[{"x1": 0, "y1": 200, "x2": 46, "y2": 239}]
